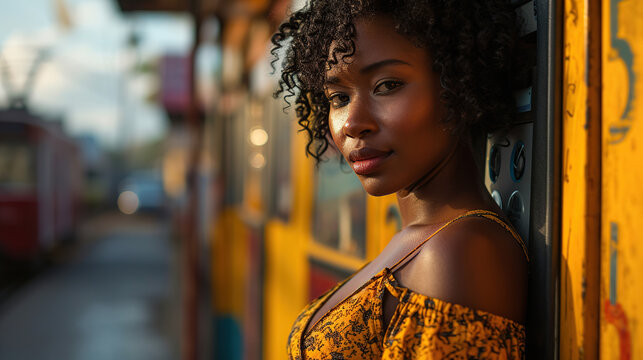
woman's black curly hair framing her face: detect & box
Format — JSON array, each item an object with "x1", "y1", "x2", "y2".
[{"x1": 271, "y1": 0, "x2": 517, "y2": 161}]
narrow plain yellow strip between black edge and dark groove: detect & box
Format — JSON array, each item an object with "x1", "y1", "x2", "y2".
[{"x1": 559, "y1": 0, "x2": 601, "y2": 360}]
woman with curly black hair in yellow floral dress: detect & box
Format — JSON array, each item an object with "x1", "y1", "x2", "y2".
[{"x1": 273, "y1": 0, "x2": 528, "y2": 359}]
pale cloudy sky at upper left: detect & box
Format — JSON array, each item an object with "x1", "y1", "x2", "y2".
[{"x1": 0, "y1": 0, "x2": 192, "y2": 147}]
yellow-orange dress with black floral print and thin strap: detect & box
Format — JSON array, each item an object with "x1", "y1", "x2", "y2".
[{"x1": 288, "y1": 210, "x2": 527, "y2": 360}]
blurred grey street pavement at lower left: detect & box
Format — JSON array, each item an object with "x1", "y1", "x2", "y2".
[{"x1": 0, "y1": 213, "x2": 180, "y2": 360}]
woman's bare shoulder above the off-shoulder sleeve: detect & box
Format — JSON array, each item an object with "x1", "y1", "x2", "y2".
[{"x1": 396, "y1": 218, "x2": 527, "y2": 323}]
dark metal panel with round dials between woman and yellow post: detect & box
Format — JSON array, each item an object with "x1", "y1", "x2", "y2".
[{"x1": 483, "y1": 0, "x2": 562, "y2": 359}]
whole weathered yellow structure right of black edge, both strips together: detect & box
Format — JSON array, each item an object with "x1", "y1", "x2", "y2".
[{"x1": 560, "y1": 0, "x2": 643, "y2": 360}]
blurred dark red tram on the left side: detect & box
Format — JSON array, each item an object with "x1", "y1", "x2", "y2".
[{"x1": 0, "y1": 109, "x2": 82, "y2": 261}]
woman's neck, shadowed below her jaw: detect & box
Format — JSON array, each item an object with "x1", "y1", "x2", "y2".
[{"x1": 397, "y1": 142, "x2": 489, "y2": 228}]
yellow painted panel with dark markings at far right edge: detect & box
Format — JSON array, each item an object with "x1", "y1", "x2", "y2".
[{"x1": 600, "y1": 0, "x2": 643, "y2": 359}]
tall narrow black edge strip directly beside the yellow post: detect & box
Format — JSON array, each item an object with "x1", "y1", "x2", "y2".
[{"x1": 527, "y1": 0, "x2": 562, "y2": 359}]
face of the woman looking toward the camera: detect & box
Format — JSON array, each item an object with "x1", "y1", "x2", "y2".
[{"x1": 325, "y1": 16, "x2": 455, "y2": 195}]
